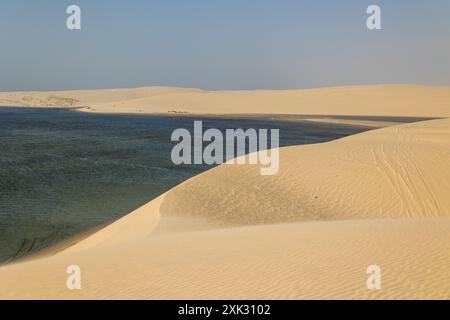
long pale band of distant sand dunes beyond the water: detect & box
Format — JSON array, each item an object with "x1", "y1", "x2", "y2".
[{"x1": 0, "y1": 85, "x2": 450, "y2": 117}]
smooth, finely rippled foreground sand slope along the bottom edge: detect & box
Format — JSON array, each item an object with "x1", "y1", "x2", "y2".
[{"x1": 0, "y1": 219, "x2": 450, "y2": 299}]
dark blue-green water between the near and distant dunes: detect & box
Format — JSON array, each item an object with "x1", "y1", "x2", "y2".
[{"x1": 0, "y1": 108, "x2": 400, "y2": 263}]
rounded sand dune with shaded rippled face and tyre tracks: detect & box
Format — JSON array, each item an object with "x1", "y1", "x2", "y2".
[{"x1": 160, "y1": 119, "x2": 450, "y2": 226}]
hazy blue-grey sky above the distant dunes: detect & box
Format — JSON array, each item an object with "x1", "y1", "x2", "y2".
[{"x1": 0, "y1": 0, "x2": 450, "y2": 91}]
